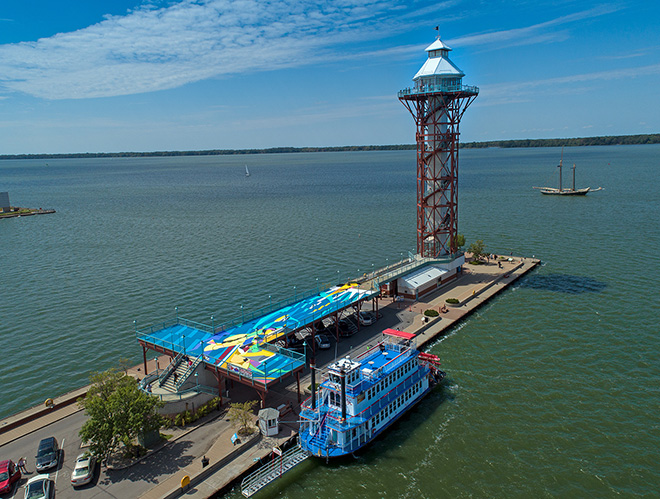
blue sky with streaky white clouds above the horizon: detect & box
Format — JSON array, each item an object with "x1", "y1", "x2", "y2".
[{"x1": 0, "y1": 0, "x2": 660, "y2": 154}]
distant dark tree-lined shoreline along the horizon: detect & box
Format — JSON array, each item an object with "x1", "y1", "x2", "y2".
[{"x1": 0, "y1": 133, "x2": 660, "y2": 160}]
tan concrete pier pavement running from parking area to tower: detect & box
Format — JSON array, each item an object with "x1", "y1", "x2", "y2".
[{"x1": 0, "y1": 256, "x2": 540, "y2": 499}]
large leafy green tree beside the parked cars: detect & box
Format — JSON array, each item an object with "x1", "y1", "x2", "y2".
[{"x1": 78, "y1": 369, "x2": 163, "y2": 459}]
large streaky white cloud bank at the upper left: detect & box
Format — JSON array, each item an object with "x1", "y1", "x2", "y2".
[{"x1": 0, "y1": 0, "x2": 422, "y2": 99}]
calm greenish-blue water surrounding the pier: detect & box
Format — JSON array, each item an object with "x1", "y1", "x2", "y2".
[{"x1": 0, "y1": 146, "x2": 660, "y2": 499}]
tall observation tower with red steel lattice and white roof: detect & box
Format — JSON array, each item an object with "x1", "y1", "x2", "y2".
[{"x1": 399, "y1": 36, "x2": 479, "y2": 258}]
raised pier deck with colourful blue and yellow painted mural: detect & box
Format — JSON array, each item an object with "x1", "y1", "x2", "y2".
[{"x1": 135, "y1": 282, "x2": 378, "y2": 406}]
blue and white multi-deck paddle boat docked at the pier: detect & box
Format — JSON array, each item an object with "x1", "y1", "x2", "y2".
[{"x1": 300, "y1": 329, "x2": 445, "y2": 458}]
